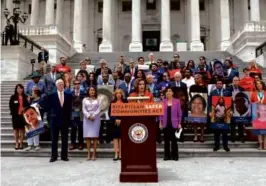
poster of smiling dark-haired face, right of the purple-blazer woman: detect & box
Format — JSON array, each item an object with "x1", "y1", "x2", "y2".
[{"x1": 187, "y1": 92, "x2": 208, "y2": 124}]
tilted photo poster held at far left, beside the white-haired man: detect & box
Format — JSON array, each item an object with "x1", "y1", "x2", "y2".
[{"x1": 23, "y1": 104, "x2": 45, "y2": 138}]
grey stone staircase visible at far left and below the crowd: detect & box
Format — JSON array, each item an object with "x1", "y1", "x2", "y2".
[{"x1": 1, "y1": 81, "x2": 266, "y2": 158}]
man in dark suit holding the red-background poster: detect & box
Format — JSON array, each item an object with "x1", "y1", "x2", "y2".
[{"x1": 210, "y1": 80, "x2": 231, "y2": 152}]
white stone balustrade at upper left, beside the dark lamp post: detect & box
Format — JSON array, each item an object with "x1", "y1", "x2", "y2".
[{"x1": 19, "y1": 25, "x2": 72, "y2": 45}]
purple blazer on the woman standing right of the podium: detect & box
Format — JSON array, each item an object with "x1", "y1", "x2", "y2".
[{"x1": 160, "y1": 98, "x2": 182, "y2": 128}]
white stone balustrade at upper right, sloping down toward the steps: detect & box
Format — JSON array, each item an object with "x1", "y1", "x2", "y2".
[{"x1": 230, "y1": 21, "x2": 266, "y2": 43}]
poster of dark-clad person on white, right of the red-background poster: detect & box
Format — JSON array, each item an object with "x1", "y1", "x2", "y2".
[{"x1": 232, "y1": 91, "x2": 252, "y2": 125}]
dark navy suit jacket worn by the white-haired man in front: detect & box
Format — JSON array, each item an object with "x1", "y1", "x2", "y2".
[{"x1": 47, "y1": 91, "x2": 72, "y2": 127}]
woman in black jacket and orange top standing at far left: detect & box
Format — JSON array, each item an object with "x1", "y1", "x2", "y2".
[{"x1": 9, "y1": 84, "x2": 29, "y2": 150}]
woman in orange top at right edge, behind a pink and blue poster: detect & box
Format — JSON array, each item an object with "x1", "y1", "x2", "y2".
[{"x1": 250, "y1": 80, "x2": 266, "y2": 150}]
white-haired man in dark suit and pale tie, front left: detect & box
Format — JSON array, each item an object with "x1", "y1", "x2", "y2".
[{"x1": 48, "y1": 79, "x2": 72, "y2": 162}]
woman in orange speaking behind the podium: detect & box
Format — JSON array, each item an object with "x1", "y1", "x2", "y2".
[{"x1": 129, "y1": 79, "x2": 154, "y2": 102}]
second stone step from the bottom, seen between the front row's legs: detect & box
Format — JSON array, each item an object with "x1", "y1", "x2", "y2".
[{"x1": 1, "y1": 140, "x2": 258, "y2": 149}]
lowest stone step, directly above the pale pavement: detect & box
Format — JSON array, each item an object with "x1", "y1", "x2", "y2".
[{"x1": 1, "y1": 148, "x2": 266, "y2": 158}]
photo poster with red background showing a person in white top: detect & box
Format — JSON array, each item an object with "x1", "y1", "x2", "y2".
[{"x1": 210, "y1": 96, "x2": 232, "y2": 130}]
